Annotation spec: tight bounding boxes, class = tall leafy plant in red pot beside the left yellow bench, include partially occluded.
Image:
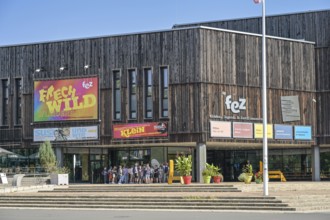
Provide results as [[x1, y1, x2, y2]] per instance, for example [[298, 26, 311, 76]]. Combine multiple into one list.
[[175, 155, 192, 184]]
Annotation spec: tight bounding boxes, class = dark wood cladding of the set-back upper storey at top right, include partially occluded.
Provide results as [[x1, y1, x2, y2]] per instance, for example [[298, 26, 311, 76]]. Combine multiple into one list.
[[174, 10, 330, 47]]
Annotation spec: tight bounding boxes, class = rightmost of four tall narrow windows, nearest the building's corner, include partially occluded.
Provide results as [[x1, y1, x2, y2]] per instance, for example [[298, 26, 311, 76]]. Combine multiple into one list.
[[160, 67, 168, 118]]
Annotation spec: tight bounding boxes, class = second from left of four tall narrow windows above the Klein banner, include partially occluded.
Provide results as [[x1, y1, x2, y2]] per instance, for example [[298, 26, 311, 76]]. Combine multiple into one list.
[[128, 69, 137, 119]]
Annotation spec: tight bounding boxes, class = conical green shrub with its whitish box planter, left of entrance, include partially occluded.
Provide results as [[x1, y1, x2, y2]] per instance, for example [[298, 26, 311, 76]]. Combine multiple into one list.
[[39, 141, 69, 185]]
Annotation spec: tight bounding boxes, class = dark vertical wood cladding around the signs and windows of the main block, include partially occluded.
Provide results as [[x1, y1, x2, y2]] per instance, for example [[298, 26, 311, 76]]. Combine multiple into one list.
[[0, 28, 315, 146]]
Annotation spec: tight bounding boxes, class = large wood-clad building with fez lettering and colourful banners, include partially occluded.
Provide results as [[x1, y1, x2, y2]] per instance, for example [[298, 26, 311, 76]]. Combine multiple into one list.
[[0, 11, 330, 183]]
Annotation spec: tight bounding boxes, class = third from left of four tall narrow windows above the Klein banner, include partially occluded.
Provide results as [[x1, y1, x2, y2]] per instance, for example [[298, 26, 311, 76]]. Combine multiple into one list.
[[144, 68, 152, 118]]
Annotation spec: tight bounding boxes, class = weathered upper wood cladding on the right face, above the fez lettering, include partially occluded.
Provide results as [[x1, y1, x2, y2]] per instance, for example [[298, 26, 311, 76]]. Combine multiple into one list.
[[201, 30, 316, 91]]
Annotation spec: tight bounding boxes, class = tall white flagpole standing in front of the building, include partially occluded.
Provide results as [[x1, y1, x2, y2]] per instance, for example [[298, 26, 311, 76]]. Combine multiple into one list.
[[262, 0, 268, 196]]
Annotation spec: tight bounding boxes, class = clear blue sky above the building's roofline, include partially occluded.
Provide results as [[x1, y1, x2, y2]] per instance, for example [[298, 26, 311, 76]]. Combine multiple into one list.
[[0, 0, 330, 46]]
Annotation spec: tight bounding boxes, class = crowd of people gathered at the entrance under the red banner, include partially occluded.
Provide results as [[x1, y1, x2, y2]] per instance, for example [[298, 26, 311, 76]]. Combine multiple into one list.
[[102, 163, 169, 184]]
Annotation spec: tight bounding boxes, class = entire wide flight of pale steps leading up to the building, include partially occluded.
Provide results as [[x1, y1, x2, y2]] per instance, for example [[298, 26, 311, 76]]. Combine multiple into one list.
[[0, 184, 295, 211]]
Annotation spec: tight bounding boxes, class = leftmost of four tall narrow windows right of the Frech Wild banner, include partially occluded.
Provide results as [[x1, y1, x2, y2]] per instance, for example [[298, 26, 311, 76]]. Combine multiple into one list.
[[113, 71, 121, 120]]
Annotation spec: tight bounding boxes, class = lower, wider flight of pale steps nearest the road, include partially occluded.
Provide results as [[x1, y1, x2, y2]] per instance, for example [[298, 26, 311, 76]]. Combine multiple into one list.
[[0, 196, 295, 211]]
